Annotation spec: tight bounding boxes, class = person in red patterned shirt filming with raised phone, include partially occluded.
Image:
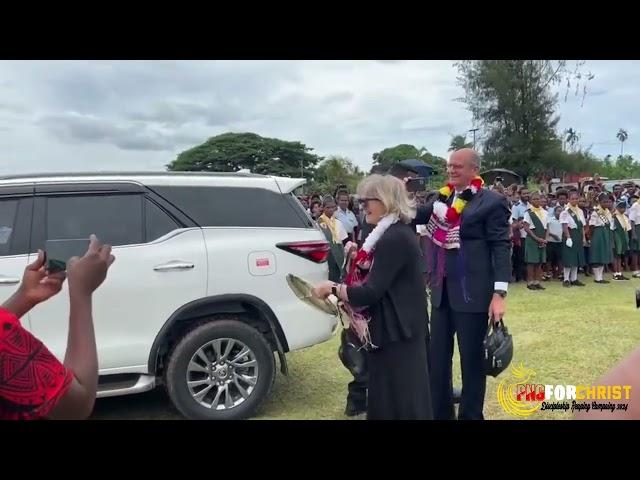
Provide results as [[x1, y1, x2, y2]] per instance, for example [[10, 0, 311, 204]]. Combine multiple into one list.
[[0, 235, 115, 420]]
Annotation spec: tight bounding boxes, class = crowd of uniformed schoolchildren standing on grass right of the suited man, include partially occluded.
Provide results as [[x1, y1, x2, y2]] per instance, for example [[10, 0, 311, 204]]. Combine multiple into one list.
[[494, 179, 640, 284]]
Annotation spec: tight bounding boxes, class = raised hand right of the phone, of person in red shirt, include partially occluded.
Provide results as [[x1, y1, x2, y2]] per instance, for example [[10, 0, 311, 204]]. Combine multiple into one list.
[[67, 235, 115, 296]]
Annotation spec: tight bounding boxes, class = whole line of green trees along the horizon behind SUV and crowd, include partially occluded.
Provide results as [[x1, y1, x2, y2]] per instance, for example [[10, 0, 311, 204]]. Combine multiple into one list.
[[168, 60, 640, 193]]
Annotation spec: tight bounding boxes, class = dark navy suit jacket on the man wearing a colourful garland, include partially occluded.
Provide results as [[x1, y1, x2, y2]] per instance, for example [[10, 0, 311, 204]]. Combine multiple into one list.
[[414, 189, 511, 313]]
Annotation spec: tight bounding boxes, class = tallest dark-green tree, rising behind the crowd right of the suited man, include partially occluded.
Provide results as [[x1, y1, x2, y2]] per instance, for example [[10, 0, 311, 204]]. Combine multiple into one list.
[[456, 60, 593, 176]]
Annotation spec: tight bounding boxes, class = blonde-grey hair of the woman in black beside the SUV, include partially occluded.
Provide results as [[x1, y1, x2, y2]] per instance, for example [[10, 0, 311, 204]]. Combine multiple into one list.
[[358, 174, 416, 223]]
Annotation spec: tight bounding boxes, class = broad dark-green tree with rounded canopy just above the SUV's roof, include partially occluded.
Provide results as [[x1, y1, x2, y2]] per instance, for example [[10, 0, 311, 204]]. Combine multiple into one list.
[[167, 133, 321, 178]]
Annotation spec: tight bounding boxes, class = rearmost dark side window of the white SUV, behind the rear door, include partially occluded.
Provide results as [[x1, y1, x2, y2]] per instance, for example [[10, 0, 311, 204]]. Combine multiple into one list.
[[153, 187, 311, 228]]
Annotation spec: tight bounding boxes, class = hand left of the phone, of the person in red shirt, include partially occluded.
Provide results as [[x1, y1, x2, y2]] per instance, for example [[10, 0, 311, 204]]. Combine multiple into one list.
[[3, 250, 65, 318]]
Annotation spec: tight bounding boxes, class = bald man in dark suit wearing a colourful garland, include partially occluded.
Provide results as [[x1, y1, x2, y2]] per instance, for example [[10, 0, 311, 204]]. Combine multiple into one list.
[[416, 148, 511, 420]]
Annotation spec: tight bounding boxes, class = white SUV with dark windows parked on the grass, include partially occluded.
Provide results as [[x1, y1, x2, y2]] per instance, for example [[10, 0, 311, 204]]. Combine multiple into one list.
[[0, 173, 338, 419]]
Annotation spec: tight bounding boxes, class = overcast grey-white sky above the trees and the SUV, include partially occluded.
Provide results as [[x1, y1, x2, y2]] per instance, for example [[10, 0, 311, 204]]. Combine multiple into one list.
[[0, 60, 640, 174]]
